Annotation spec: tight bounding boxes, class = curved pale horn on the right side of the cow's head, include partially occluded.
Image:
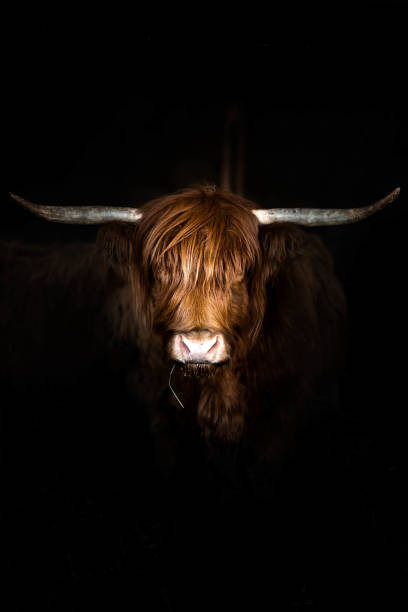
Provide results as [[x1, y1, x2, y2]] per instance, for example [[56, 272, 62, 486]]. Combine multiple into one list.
[[252, 187, 401, 226]]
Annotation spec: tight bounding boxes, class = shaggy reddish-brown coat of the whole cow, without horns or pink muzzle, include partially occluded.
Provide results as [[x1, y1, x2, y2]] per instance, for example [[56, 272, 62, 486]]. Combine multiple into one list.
[[0, 187, 346, 468]]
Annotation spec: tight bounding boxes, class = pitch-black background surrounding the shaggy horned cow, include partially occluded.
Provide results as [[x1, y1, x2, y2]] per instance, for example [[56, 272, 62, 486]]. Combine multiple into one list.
[[1, 2, 408, 610]]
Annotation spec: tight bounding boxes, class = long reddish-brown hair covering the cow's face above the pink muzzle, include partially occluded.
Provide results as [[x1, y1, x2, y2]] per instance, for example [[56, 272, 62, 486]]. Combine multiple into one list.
[[138, 186, 260, 334]]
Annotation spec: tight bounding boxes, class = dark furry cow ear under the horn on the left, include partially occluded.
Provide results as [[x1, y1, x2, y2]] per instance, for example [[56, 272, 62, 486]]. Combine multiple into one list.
[[96, 223, 137, 271]]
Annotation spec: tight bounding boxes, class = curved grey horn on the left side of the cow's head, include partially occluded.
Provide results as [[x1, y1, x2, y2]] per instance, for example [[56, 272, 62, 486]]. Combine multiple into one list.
[[10, 193, 142, 225]]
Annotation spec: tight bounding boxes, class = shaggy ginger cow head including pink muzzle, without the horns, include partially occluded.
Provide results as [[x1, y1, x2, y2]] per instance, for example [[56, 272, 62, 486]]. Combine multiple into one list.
[[135, 187, 264, 368]]
